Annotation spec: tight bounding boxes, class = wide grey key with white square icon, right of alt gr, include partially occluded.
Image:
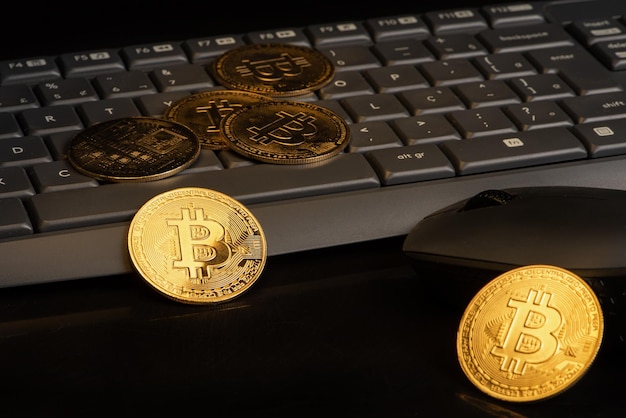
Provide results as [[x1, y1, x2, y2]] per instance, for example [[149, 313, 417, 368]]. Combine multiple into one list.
[[440, 128, 587, 175]]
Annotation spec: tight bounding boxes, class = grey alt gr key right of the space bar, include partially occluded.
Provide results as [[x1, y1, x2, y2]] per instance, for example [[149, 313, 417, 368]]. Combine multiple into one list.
[[365, 144, 455, 186]]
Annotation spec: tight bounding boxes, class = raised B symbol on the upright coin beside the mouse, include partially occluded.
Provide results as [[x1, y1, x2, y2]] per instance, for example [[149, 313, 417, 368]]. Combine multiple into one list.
[[491, 290, 562, 374]]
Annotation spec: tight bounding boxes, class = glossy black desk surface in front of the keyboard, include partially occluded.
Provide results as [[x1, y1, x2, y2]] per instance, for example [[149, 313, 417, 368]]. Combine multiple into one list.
[[0, 239, 626, 417]]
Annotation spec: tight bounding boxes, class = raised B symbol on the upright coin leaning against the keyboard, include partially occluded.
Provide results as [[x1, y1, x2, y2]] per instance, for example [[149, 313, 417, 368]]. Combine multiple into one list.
[[167, 208, 231, 279]]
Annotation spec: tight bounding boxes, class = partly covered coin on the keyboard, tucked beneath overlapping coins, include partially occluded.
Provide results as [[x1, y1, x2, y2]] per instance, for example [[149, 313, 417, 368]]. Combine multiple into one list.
[[163, 90, 273, 150]]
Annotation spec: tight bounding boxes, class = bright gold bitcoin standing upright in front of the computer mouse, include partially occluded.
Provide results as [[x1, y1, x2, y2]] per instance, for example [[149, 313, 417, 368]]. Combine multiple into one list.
[[457, 265, 604, 402]]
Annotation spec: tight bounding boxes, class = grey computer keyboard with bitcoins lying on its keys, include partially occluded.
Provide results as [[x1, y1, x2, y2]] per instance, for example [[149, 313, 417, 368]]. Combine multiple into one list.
[[0, 1, 626, 287]]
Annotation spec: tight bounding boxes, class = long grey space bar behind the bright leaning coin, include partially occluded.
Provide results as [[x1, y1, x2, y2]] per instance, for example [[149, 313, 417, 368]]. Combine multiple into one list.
[[28, 154, 380, 232]]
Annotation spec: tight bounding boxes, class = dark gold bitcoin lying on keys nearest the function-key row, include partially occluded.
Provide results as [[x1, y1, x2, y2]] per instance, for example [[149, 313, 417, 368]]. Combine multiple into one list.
[[213, 43, 335, 97]]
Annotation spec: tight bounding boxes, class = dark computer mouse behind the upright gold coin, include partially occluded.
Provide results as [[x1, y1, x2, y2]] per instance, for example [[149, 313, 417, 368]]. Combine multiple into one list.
[[402, 186, 626, 318]]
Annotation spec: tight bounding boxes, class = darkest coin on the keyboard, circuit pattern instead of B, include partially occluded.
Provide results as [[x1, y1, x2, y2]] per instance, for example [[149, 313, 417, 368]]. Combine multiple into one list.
[[67, 117, 200, 182]]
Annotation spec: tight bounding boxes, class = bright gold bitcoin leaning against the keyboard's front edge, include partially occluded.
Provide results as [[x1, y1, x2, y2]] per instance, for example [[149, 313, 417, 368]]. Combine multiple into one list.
[[128, 187, 267, 304]]
